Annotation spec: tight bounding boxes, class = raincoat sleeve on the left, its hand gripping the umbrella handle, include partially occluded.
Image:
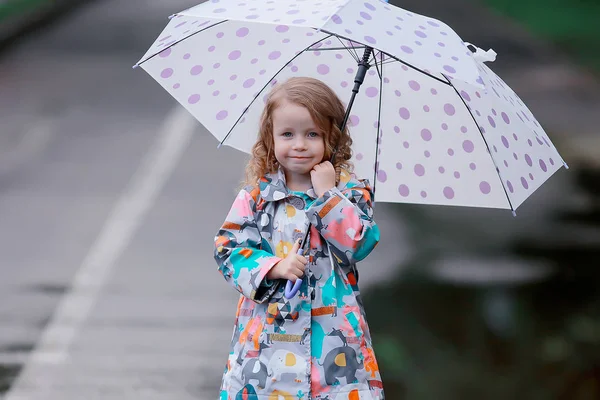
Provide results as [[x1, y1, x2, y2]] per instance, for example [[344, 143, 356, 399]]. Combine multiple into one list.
[[214, 189, 281, 303]]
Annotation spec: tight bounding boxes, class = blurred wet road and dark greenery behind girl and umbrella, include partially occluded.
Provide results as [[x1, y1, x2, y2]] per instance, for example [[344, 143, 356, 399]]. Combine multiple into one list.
[[0, 0, 600, 400]]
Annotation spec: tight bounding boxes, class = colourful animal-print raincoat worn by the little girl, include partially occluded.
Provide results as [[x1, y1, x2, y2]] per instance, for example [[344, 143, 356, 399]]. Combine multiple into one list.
[[215, 171, 384, 400]]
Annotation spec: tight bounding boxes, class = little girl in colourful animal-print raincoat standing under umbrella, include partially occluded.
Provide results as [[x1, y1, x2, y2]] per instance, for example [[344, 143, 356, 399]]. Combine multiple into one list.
[[215, 78, 384, 400]]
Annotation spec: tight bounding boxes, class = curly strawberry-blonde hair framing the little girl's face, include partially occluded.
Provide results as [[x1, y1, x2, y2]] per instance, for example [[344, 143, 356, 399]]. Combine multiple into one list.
[[244, 77, 353, 185]]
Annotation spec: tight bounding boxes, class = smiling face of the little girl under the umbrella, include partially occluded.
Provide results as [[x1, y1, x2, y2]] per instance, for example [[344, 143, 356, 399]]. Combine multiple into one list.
[[272, 100, 325, 182]]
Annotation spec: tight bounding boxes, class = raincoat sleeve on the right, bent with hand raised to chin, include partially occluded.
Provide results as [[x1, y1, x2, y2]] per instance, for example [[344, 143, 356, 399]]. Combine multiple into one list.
[[307, 180, 379, 265]]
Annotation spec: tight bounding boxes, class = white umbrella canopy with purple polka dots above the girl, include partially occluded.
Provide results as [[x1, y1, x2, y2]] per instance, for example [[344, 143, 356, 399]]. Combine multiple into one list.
[[139, 0, 563, 210]]
